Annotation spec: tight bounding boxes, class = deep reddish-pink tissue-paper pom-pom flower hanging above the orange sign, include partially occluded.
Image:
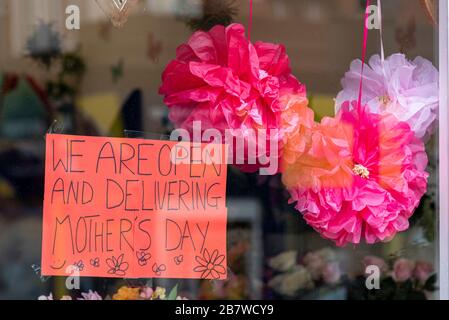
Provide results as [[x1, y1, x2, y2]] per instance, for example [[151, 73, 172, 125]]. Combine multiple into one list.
[[159, 24, 306, 172]]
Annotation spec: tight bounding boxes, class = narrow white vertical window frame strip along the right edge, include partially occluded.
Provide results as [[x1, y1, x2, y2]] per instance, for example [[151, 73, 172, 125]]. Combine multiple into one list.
[[438, 0, 449, 300]]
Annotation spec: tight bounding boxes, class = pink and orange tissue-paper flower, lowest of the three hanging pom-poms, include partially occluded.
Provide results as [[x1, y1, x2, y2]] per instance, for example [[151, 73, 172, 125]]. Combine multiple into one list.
[[283, 102, 428, 246]]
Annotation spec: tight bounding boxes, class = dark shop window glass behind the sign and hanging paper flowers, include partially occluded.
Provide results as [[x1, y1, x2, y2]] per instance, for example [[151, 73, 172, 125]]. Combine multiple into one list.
[[0, 0, 439, 300]]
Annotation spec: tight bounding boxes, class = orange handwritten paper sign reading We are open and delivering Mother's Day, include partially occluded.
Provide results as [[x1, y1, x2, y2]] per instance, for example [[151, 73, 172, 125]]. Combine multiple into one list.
[[42, 134, 227, 279]]
